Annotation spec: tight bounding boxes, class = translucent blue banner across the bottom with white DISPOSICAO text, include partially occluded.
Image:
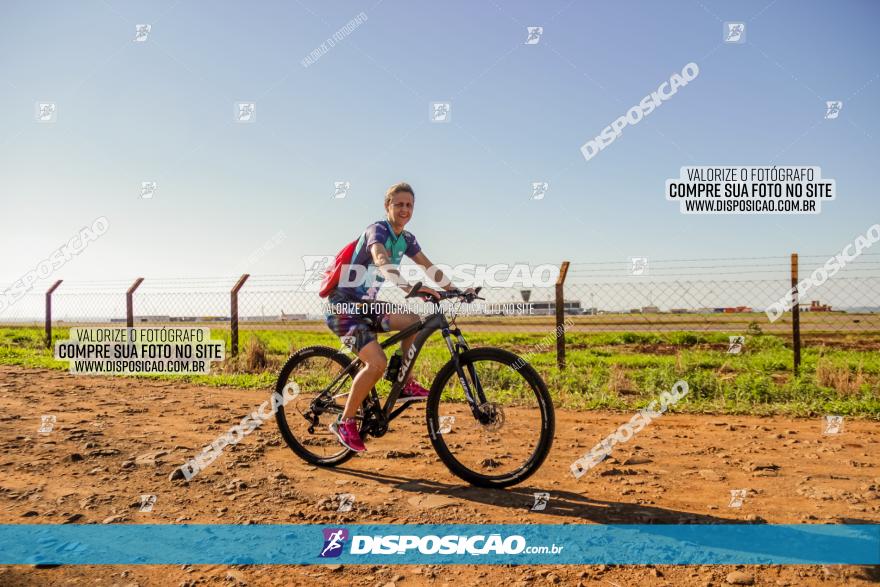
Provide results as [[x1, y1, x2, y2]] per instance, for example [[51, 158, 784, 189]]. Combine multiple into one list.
[[0, 524, 880, 565]]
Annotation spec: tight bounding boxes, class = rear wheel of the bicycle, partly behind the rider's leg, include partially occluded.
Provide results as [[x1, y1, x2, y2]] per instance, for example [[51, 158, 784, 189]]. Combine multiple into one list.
[[275, 346, 363, 467]]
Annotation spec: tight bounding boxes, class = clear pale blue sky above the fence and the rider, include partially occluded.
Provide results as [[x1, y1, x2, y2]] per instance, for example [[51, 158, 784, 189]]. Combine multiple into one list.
[[0, 0, 880, 283]]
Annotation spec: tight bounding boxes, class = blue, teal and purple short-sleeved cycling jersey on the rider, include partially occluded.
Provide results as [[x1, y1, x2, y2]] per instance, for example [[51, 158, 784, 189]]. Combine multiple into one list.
[[336, 220, 422, 302]]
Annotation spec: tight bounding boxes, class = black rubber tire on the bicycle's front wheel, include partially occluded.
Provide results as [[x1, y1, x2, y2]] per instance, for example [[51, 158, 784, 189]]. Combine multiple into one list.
[[425, 347, 556, 488]]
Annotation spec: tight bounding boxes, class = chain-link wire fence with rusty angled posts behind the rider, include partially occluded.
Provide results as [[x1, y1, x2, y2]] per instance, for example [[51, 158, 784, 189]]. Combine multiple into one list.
[[0, 253, 880, 372]]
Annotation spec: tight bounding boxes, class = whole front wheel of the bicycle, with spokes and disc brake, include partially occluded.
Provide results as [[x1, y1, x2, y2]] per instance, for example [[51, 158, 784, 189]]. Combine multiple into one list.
[[426, 348, 555, 487]]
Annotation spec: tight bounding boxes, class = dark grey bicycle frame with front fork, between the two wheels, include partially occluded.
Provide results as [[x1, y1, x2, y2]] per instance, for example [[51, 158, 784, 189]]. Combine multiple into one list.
[[313, 308, 486, 437]]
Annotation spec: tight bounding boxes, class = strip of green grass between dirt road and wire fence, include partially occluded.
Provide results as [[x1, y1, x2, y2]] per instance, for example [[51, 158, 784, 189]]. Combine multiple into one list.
[[0, 327, 880, 419]]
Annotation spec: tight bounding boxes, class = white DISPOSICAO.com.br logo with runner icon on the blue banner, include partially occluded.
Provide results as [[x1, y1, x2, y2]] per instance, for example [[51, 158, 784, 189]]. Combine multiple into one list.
[[319, 528, 564, 558]]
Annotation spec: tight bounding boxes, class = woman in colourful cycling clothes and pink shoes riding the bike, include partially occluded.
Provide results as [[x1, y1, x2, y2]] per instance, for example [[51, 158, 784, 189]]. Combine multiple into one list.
[[327, 183, 473, 452]]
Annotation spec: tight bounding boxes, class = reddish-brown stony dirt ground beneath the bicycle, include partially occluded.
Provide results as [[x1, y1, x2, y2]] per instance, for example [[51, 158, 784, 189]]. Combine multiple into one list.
[[0, 366, 880, 587]]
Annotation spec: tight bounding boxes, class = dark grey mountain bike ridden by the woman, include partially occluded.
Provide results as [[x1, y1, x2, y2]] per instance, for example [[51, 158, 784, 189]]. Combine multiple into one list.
[[275, 283, 555, 488]]
